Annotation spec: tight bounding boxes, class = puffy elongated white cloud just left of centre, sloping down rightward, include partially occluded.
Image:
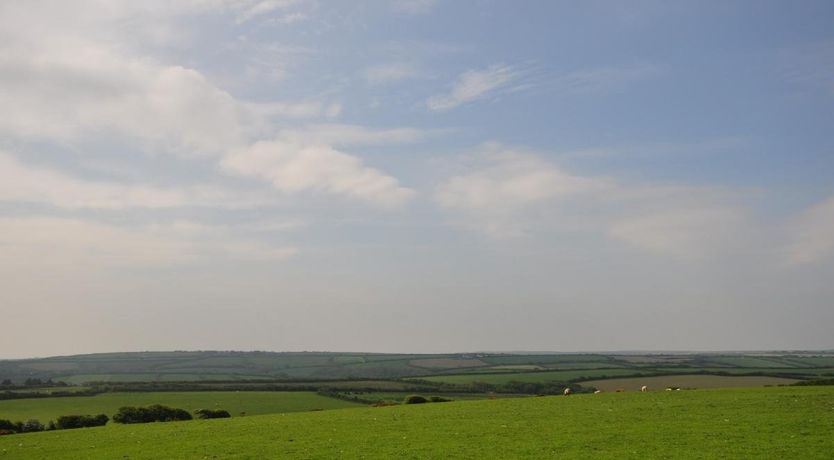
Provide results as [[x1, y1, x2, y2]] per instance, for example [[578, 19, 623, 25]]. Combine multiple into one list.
[[222, 140, 414, 207]]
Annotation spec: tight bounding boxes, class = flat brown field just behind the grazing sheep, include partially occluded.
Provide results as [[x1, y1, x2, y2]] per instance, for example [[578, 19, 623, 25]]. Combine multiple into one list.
[[579, 374, 798, 391]]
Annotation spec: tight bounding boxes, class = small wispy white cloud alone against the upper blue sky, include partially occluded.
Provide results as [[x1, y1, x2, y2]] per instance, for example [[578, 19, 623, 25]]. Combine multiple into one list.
[[426, 65, 523, 111]]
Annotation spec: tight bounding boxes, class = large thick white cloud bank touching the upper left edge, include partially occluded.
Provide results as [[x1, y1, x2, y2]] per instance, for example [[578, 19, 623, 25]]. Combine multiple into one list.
[[0, 36, 250, 155]]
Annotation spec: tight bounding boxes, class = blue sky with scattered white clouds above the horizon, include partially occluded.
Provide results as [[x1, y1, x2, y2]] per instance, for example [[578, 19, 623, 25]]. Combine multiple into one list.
[[0, 0, 834, 358]]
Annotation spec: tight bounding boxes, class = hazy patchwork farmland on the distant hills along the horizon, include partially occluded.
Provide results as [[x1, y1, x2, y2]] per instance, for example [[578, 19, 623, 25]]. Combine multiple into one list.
[[0, 351, 834, 385]]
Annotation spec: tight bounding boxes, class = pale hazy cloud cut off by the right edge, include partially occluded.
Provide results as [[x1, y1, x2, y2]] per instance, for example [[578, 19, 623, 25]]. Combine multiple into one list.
[[788, 197, 834, 265]]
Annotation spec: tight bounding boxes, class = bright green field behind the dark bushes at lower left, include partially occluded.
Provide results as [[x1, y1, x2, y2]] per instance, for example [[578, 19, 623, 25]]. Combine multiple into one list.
[[0, 391, 357, 423]]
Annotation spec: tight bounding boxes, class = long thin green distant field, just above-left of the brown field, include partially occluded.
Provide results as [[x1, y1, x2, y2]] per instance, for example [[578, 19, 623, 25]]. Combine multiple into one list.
[[420, 368, 651, 384]]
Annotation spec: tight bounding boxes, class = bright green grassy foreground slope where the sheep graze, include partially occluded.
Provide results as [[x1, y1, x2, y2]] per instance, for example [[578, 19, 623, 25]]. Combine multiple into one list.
[[0, 387, 834, 459]]
